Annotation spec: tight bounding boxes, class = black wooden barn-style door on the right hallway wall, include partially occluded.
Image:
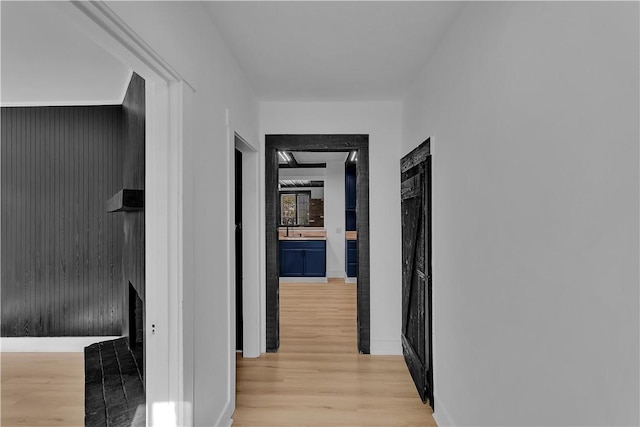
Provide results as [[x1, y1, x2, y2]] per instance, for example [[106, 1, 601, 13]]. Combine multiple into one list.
[[400, 140, 433, 408]]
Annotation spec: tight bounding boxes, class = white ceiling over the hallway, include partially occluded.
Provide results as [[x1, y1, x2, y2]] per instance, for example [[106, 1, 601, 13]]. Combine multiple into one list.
[[206, 1, 464, 100]]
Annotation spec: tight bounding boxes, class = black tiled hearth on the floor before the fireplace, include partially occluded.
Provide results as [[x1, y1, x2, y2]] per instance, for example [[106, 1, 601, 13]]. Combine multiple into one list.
[[84, 338, 146, 427]]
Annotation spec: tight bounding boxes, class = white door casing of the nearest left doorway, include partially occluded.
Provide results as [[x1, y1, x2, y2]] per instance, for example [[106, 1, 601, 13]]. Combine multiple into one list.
[[57, 2, 193, 416]]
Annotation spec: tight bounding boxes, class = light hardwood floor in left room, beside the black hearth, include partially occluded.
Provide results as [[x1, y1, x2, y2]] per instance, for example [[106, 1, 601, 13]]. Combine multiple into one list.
[[0, 353, 84, 427]]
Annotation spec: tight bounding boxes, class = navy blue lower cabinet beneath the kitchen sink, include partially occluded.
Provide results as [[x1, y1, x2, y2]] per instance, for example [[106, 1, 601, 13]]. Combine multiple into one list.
[[280, 240, 327, 277]]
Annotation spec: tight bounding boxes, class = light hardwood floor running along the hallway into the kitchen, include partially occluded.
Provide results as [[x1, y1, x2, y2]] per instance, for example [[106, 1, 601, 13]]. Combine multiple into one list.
[[233, 282, 436, 427]]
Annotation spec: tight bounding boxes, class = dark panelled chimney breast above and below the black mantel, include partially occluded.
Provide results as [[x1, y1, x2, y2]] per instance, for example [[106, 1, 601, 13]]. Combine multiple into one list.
[[120, 73, 145, 336]]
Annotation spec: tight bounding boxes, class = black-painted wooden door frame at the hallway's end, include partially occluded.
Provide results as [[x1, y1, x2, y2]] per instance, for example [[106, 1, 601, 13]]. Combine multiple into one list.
[[265, 135, 371, 354]]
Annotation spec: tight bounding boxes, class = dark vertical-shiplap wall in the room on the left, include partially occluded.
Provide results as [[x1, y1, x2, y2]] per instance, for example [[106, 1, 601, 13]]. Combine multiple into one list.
[[1, 106, 123, 336]]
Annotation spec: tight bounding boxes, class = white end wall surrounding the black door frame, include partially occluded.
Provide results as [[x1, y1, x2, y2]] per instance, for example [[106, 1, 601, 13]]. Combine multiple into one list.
[[260, 102, 401, 354]]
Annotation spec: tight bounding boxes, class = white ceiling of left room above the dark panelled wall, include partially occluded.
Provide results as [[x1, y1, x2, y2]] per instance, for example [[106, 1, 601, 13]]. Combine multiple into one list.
[[0, 1, 131, 105]]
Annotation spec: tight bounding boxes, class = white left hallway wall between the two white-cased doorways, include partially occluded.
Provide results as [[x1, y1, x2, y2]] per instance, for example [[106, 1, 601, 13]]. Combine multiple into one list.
[[109, 2, 258, 426]]
